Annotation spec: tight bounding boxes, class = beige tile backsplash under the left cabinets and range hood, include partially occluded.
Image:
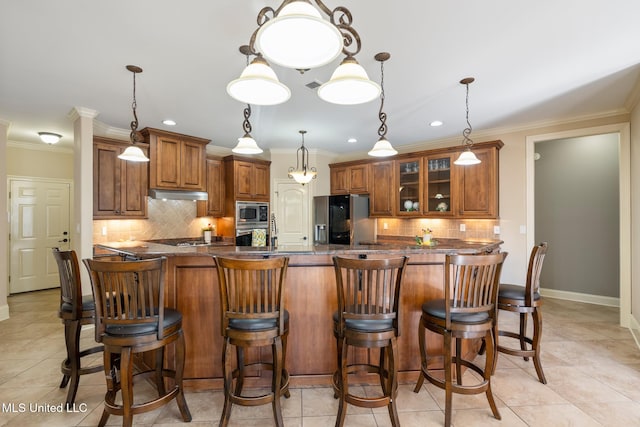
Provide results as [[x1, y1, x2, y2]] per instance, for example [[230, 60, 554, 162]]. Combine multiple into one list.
[[93, 199, 216, 243]]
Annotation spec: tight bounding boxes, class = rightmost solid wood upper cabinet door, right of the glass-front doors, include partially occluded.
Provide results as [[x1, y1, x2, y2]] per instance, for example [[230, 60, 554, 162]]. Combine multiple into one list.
[[456, 147, 498, 218]]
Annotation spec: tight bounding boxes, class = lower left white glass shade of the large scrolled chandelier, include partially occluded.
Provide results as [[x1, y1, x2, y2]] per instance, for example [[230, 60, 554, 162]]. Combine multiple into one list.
[[227, 56, 291, 105]]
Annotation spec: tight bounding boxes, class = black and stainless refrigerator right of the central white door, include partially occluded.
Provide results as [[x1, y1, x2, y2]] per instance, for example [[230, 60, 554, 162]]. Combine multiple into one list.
[[313, 194, 376, 245]]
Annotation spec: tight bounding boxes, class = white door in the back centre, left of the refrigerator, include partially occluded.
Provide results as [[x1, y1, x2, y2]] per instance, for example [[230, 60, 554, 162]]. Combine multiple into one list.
[[275, 181, 311, 246]]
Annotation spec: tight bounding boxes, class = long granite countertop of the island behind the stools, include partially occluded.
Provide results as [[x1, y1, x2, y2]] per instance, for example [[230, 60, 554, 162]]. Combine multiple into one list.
[[96, 238, 504, 258]]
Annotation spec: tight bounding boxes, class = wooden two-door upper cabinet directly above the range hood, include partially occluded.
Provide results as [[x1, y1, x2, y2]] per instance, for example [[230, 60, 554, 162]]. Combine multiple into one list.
[[142, 128, 209, 191]]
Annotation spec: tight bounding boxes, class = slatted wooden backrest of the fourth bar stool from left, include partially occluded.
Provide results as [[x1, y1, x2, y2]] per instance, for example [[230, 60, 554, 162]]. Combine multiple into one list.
[[333, 256, 409, 335]]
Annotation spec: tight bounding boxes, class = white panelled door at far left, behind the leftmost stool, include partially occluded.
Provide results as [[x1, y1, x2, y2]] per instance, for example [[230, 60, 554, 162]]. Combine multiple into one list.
[[9, 179, 70, 294]]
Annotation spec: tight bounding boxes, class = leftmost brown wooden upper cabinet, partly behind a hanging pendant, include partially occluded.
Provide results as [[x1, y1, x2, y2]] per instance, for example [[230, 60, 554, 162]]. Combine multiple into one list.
[[93, 136, 148, 219]]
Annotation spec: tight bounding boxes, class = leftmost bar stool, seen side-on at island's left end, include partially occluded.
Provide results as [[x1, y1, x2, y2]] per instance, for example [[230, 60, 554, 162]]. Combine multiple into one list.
[[53, 248, 103, 407]]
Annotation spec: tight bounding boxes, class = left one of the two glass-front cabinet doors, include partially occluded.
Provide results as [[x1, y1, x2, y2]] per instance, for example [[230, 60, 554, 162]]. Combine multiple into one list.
[[396, 157, 422, 216]]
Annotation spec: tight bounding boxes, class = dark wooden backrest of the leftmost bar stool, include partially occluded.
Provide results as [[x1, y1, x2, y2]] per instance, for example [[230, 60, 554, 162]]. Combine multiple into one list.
[[53, 248, 82, 319]]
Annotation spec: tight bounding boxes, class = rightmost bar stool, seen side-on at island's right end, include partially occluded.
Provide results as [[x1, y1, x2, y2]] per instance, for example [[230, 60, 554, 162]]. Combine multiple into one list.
[[494, 242, 547, 384]]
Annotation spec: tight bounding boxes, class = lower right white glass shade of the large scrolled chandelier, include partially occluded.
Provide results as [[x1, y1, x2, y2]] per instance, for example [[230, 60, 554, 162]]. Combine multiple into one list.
[[318, 58, 381, 105]]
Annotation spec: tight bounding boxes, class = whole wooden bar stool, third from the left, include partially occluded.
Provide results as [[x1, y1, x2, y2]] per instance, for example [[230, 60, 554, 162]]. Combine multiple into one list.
[[214, 257, 290, 427]]
